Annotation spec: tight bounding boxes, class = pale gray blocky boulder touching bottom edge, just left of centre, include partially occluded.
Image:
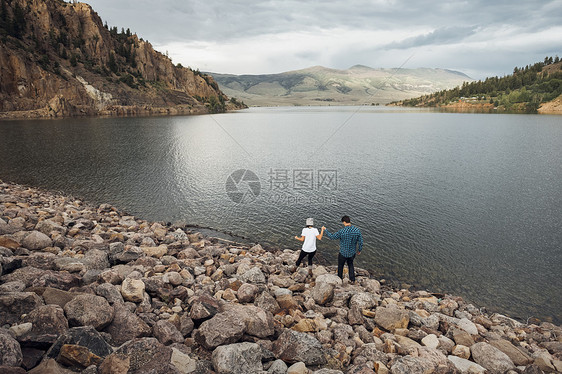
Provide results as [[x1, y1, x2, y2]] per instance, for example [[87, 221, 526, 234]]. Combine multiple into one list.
[[212, 342, 263, 374]]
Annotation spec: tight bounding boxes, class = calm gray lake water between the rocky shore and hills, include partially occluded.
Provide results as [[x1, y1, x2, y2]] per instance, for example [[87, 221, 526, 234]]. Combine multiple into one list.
[[0, 107, 562, 324]]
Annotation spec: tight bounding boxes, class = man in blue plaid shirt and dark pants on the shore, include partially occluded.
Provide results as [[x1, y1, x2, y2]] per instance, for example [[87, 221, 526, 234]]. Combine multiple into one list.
[[322, 216, 363, 283]]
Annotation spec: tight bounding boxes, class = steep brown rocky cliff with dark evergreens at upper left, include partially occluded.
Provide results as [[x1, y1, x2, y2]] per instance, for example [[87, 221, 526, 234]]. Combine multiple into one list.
[[0, 0, 243, 118]]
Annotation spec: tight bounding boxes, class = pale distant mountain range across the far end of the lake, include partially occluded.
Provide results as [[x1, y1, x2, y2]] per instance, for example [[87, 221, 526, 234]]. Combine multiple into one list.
[[209, 65, 473, 106]]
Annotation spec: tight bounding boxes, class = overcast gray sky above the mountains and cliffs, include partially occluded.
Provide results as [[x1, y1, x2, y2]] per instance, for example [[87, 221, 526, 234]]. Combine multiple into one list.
[[86, 0, 562, 79]]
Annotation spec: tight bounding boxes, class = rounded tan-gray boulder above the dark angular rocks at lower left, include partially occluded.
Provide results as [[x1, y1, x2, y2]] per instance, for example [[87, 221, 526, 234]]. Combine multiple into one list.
[[64, 294, 114, 330]]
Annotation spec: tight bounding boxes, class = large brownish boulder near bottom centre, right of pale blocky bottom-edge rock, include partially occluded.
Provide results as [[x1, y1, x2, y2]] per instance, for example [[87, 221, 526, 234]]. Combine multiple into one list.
[[272, 329, 327, 366]]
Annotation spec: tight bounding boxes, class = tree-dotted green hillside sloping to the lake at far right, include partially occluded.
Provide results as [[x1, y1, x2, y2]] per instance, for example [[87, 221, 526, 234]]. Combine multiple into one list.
[[393, 56, 562, 113]]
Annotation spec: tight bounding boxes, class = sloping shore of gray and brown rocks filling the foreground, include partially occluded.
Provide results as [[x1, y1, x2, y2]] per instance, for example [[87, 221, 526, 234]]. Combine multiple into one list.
[[0, 181, 562, 374]]
